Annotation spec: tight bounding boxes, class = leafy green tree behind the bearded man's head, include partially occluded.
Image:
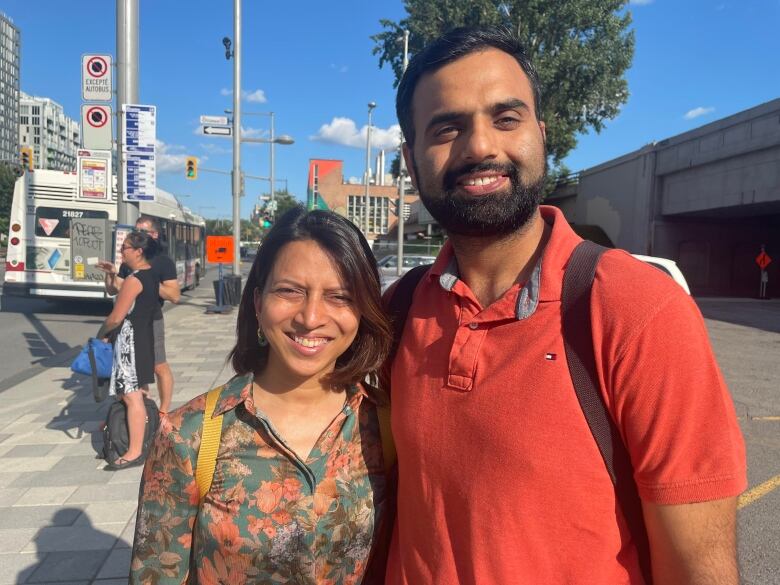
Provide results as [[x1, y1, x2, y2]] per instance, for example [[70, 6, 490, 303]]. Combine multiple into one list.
[[371, 0, 634, 167]]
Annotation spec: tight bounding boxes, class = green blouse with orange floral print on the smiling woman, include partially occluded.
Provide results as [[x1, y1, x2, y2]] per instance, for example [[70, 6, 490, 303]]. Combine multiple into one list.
[[130, 375, 394, 585]]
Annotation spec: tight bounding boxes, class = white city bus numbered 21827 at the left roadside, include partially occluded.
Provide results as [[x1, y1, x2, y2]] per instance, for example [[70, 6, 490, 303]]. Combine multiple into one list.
[[3, 170, 206, 300]]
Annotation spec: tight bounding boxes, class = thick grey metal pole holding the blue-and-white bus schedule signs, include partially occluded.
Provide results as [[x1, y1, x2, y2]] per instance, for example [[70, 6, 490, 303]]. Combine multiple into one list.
[[116, 0, 138, 225]]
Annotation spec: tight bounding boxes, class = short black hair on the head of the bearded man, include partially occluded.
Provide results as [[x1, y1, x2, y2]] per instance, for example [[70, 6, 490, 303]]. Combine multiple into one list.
[[395, 27, 541, 147]]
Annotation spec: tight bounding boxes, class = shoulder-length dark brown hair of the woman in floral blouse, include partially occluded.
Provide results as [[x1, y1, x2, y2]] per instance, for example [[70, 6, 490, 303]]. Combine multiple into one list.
[[229, 207, 392, 386]]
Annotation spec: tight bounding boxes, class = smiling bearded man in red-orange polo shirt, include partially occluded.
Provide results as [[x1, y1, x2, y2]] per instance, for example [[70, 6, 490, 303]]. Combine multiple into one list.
[[387, 29, 746, 585]]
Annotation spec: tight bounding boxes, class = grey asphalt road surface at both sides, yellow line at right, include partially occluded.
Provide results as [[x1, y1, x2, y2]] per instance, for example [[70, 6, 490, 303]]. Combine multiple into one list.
[[0, 262, 780, 585]]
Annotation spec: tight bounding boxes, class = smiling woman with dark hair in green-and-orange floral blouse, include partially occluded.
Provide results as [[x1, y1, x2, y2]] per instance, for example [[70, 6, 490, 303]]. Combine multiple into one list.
[[131, 209, 391, 585]]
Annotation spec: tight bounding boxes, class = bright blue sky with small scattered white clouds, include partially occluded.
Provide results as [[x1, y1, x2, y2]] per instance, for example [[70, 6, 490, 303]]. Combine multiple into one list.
[[0, 0, 780, 217]]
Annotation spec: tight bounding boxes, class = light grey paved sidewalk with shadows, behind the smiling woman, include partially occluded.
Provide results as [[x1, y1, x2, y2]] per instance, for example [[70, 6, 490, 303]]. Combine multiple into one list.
[[0, 286, 238, 585]]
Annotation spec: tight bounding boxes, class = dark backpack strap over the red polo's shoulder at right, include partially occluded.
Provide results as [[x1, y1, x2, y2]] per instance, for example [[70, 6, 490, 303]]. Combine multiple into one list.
[[561, 240, 652, 583]]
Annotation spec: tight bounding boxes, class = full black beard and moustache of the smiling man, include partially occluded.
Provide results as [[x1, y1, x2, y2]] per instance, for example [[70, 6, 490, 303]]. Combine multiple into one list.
[[414, 155, 547, 237]]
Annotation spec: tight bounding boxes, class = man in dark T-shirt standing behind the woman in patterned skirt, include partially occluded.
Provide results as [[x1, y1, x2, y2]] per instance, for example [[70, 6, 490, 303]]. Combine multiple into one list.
[[97, 215, 181, 414]]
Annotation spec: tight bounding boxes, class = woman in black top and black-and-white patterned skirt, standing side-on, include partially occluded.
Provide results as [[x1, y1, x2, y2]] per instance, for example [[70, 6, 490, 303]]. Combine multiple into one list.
[[97, 232, 160, 469]]
